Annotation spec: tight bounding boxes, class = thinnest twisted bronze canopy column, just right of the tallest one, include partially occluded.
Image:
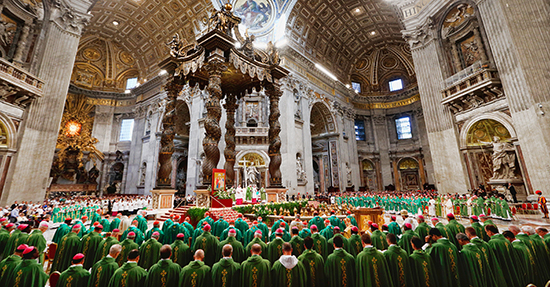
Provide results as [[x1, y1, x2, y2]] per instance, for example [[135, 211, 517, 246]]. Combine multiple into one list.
[[223, 95, 237, 187]]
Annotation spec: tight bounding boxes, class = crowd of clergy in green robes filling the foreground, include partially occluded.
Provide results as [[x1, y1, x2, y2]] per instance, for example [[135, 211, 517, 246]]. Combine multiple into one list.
[[0, 194, 550, 287]]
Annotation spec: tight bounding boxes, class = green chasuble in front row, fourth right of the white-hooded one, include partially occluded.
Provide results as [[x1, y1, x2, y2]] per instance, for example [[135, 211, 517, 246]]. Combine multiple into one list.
[[384, 245, 413, 287]]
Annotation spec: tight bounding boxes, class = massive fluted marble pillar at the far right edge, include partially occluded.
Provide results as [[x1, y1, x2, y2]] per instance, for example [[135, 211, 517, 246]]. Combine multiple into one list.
[[478, 0, 550, 193]]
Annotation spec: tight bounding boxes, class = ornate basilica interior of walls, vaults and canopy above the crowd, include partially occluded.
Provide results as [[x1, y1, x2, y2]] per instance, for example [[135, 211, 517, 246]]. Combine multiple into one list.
[[0, 0, 550, 205]]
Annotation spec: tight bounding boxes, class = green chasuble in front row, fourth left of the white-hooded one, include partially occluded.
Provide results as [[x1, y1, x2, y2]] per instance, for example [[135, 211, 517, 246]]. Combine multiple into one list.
[[145, 259, 181, 287]]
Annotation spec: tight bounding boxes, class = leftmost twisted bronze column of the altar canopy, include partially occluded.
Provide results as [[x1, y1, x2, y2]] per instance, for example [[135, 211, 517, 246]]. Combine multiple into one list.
[[157, 78, 183, 188]]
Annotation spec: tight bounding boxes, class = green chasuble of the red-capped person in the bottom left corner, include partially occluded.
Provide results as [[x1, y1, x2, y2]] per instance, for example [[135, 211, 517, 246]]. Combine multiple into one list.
[[2, 259, 48, 287]]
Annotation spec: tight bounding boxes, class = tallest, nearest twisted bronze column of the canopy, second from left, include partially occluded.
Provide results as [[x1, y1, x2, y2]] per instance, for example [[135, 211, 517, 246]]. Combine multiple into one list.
[[202, 59, 227, 186]]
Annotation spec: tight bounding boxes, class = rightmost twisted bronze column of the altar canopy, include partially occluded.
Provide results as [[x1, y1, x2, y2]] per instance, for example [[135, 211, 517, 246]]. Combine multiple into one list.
[[265, 82, 283, 187]]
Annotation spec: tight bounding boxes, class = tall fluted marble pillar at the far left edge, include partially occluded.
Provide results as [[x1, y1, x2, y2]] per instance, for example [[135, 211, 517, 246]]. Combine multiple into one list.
[[0, 0, 92, 205]]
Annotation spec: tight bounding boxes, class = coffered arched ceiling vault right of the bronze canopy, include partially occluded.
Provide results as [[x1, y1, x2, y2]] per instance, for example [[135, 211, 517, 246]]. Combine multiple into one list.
[[286, 0, 405, 82]]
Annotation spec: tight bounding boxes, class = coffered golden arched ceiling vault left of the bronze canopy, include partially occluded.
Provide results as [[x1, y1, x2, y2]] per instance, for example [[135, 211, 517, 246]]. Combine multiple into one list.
[[83, 0, 214, 77]]
